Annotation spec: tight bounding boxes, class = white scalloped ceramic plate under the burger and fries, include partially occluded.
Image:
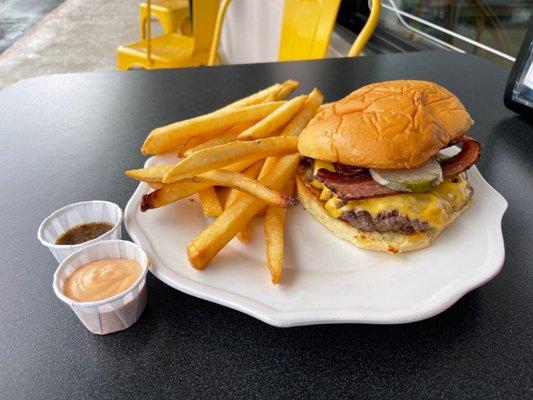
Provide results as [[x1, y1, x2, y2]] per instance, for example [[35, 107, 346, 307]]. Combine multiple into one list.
[[125, 149, 507, 327]]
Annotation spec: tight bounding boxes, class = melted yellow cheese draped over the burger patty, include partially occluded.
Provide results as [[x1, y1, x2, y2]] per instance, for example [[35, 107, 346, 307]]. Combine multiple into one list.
[[312, 161, 470, 229]]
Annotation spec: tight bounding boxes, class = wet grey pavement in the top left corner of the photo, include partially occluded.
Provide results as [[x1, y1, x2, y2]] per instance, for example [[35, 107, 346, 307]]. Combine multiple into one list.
[[0, 0, 64, 53]]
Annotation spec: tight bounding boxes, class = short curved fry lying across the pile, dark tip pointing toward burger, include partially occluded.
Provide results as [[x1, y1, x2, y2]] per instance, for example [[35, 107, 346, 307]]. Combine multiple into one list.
[[188, 169, 296, 208]]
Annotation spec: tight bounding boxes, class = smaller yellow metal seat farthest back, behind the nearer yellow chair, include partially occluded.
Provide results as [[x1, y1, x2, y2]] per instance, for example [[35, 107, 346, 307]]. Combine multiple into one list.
[[139, 0, 189, 39]]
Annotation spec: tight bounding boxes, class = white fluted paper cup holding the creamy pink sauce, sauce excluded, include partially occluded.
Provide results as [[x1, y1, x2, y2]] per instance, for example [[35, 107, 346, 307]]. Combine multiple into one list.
[[53, 240, 150, 335]]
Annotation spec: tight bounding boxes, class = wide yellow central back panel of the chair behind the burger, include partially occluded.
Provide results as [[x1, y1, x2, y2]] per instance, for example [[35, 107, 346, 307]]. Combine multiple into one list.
[[278, 0, 340, 61]]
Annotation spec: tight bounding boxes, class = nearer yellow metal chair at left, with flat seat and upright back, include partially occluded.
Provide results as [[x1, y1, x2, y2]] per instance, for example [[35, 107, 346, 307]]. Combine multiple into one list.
[[117, 0, 220, 71]]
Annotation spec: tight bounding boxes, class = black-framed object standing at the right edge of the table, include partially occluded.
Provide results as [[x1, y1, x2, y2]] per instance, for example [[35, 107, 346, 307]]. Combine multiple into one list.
[[503, 17, 533, 118]]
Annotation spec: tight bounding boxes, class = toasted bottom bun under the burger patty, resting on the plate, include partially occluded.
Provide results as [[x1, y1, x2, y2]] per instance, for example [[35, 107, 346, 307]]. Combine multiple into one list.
[[296, 173, 473, 253]]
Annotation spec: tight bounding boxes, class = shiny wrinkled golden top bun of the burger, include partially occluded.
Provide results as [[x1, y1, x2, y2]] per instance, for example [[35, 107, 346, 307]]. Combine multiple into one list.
[[298, 80, 474, 169]]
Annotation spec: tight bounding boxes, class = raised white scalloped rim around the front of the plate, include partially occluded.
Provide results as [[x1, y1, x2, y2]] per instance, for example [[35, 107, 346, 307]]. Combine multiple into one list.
[[124, 157, 508, 327]]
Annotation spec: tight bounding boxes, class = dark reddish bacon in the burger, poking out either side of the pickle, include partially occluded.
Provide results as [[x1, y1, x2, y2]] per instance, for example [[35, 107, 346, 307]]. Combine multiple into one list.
[[315, 138, 481, 201]]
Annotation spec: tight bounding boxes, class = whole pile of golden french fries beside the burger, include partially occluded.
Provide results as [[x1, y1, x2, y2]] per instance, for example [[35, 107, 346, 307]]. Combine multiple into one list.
[[126, 80, 323, 284]]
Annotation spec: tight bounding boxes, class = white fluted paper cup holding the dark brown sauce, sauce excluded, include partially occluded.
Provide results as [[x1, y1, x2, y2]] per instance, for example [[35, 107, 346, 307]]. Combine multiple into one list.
[[37, 200, 124, 262]]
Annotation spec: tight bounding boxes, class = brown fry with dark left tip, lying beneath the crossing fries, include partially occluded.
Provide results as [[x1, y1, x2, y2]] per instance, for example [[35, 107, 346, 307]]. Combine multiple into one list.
[[141, 160, 255, 211]]
